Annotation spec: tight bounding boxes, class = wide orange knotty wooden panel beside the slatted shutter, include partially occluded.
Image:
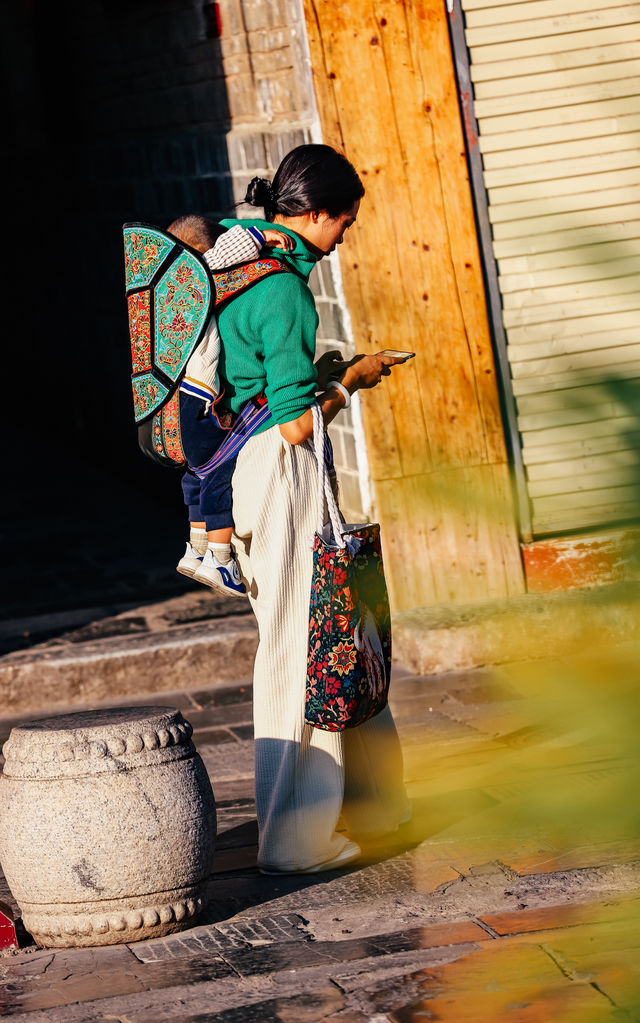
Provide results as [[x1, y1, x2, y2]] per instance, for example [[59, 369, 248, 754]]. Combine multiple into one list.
[[305, 0, 523, 609]]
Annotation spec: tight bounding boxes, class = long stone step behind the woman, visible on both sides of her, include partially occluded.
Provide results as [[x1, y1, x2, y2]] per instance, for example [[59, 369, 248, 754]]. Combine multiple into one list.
[[0, 583, 640, 715]]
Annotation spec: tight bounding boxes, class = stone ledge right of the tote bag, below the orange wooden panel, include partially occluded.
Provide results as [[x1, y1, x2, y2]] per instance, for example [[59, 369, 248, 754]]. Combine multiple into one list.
[[394, 583, 640, 675]]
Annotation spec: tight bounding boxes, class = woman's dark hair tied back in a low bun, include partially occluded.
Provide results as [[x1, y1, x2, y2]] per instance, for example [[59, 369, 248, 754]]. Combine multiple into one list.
[[244, 145, 364, 220]]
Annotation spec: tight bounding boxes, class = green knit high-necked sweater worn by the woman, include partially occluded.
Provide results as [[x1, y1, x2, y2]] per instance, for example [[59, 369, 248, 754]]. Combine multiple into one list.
[[218, 219, 318, 433]]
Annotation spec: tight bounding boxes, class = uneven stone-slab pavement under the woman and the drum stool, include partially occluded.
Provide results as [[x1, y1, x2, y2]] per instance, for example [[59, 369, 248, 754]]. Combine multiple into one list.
[[0, 646, 640, 1023]]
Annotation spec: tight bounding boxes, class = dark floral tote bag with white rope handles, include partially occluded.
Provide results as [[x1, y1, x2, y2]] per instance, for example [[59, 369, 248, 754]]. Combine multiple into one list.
[[305, 405, 392, 731]]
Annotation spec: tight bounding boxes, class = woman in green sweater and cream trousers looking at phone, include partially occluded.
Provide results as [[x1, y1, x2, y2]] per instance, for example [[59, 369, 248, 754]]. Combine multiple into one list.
[[219, 145, 409, 874]]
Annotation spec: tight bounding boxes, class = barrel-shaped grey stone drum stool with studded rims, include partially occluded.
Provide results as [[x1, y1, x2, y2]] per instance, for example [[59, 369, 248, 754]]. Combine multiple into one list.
[[0, 707, 216, 947]]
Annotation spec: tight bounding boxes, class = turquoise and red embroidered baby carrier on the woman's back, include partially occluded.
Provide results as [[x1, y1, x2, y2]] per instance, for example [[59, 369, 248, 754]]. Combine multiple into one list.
[[123, 223, 288, 466]]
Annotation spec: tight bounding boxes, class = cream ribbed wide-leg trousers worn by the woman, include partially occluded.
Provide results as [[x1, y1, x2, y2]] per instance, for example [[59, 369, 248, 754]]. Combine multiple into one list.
[[233, 427, 408, 871]]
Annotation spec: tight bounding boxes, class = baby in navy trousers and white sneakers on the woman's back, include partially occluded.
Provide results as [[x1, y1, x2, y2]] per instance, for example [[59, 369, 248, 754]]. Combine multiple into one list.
[[168, 215, 293, 596]]
